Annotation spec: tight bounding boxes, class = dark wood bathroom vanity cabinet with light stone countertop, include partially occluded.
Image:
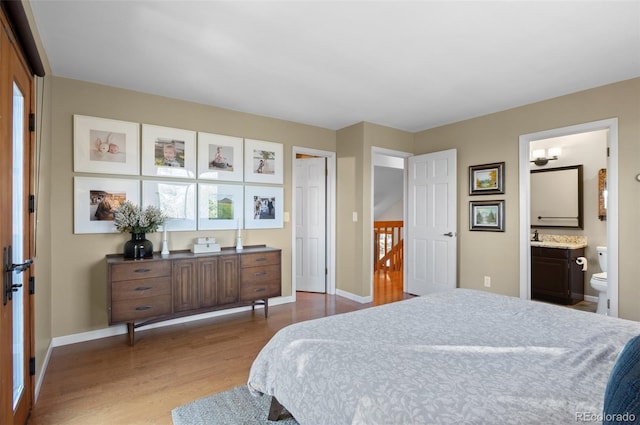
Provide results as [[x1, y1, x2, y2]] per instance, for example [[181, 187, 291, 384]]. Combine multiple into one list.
[[531, 242, 585, 305]]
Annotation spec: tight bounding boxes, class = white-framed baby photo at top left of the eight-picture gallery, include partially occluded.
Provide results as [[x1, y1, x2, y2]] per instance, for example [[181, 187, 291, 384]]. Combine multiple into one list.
[[73, 115, 140, 175]]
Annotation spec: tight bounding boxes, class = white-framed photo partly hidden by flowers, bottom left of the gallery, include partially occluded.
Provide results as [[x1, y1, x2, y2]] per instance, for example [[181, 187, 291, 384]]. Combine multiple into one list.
[[73, 177, 140, 233]]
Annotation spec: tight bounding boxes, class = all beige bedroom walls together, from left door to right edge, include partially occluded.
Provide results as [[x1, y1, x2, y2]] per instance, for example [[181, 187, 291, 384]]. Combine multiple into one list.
[[42, 78, 640, 344]]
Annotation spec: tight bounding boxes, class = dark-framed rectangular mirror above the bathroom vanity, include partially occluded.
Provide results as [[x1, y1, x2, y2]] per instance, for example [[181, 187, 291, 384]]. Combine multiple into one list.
[[531, 165, 584, 229]]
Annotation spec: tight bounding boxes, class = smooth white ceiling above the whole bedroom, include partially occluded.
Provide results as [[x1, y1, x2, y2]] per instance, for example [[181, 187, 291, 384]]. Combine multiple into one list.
[[30, 0, 640, 131]]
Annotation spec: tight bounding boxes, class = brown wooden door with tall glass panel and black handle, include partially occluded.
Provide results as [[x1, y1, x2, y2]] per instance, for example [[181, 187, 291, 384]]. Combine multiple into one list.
[[0, 7, 34, 425]]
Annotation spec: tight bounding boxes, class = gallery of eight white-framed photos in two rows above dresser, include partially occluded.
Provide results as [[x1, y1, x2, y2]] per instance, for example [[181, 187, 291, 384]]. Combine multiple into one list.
[[73, 115, 284, 234]]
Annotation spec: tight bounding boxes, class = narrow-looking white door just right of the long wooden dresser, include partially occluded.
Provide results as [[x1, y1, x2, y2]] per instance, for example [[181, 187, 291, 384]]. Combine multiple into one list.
[[295, 158, 327, 292]]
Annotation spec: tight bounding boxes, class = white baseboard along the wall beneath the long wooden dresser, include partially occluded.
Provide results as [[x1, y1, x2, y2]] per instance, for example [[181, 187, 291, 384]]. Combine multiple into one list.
[[51, 296, 295, 347]]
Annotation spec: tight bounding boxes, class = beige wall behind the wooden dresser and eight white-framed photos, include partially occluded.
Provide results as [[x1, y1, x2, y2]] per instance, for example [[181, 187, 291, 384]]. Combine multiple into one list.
[[48, 77, 336, 337]]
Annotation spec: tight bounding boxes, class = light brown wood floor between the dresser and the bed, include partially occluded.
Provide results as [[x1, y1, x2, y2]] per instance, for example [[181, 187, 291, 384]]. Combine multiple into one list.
[[29, 273, 409, 425]]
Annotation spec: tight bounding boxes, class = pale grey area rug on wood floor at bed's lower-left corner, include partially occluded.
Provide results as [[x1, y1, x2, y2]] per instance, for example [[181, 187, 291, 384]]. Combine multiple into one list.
[[171, 385, 298, 425]]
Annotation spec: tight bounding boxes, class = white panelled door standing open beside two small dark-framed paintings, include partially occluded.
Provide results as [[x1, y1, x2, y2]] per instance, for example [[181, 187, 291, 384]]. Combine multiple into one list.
[[405, 149, 457, 295]]
